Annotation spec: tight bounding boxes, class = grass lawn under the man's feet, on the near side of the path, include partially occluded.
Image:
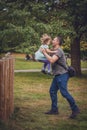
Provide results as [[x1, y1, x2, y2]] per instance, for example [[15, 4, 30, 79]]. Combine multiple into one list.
[[0, 71, 87, 130]]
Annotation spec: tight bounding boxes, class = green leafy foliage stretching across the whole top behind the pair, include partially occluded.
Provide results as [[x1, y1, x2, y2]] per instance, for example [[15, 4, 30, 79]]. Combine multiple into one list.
[[0, 0, 87, 53]]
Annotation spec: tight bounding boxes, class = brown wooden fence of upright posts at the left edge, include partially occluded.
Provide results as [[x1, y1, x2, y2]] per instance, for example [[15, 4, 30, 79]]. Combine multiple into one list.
[[0, 56, 14, 121]]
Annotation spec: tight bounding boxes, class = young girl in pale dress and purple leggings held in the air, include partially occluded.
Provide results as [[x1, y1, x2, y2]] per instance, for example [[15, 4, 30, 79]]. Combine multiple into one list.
[[35, 34, 51, 74]]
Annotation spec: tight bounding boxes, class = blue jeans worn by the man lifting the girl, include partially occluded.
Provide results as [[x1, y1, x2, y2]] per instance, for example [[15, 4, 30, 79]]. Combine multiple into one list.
[[50, 73, 78, 111]]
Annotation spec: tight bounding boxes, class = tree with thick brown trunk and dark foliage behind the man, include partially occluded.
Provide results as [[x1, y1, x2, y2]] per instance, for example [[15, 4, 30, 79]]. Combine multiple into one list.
[[45, 0, 87, 76]]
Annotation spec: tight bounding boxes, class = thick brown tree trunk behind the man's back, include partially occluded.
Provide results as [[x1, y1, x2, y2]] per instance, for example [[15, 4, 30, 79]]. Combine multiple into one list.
[[71, 37, 81, 76]]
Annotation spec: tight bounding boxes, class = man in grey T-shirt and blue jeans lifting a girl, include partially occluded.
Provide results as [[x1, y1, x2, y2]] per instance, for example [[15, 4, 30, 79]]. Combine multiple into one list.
[[42, 37, 80, 118]]
